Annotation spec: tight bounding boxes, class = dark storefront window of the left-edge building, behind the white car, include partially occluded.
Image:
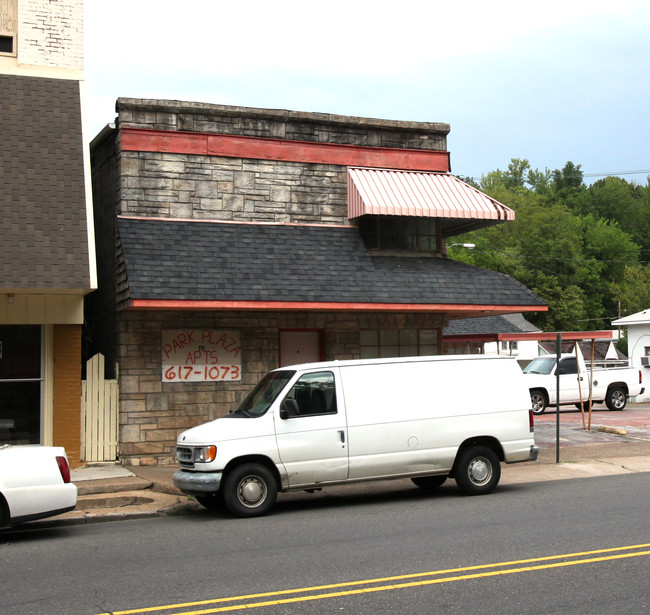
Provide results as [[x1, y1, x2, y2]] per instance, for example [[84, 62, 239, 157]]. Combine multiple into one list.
[[0, 325, 43, 444]]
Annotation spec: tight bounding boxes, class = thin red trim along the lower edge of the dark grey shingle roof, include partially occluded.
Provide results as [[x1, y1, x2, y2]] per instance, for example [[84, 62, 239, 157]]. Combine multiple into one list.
[[130, 299, 548, 314]]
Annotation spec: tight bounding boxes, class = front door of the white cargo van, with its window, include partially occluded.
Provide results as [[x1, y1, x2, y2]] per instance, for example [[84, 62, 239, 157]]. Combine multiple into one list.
[[274, 371, 348, 487]]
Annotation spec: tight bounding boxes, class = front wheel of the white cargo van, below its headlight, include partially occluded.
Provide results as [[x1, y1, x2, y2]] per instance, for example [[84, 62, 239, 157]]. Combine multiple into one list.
[[223, 463, 278, 517]]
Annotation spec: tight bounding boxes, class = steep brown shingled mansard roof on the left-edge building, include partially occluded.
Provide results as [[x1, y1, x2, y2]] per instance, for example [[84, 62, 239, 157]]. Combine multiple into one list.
[[0, 75, 94, 292]]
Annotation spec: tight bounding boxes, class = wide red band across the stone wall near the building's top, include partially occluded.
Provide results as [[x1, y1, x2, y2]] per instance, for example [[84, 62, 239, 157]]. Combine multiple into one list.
[[121, 128, 450, 173]]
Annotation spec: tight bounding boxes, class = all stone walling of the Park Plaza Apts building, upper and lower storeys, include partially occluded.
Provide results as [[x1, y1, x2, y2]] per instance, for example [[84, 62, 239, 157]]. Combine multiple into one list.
[[87, 99, 456, 465]]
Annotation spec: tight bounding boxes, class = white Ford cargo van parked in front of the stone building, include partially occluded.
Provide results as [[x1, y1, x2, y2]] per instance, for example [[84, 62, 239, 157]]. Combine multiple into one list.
[[174, 356, 538, 517]]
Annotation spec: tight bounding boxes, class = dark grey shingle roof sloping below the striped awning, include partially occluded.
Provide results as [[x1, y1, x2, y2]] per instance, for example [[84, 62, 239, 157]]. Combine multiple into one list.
[[118, 218, 546, 307]]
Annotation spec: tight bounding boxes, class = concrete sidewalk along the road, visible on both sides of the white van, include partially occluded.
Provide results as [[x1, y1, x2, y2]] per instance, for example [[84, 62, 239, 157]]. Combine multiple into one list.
[[25, 415, 650, 527]]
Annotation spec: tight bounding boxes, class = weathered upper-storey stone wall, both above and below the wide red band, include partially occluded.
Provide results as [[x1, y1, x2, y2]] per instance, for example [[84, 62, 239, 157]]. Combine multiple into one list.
[[112, 98, 449, 224]]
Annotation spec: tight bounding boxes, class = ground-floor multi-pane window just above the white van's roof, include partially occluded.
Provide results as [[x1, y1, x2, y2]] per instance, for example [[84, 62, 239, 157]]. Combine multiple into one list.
[[360, 329, 438, 359]]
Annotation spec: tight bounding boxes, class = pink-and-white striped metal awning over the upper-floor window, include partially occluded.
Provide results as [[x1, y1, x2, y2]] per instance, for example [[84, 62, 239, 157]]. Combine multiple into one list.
[[348, 167, 515, 237]]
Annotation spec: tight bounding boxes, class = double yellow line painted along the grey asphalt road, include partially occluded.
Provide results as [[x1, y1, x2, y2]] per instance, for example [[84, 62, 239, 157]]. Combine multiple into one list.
[[100, 543, 650, 615]]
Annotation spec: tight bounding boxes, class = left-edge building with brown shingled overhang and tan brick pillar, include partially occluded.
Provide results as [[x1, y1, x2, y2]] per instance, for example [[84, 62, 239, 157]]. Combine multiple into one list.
[[0, 0, 96, 465]]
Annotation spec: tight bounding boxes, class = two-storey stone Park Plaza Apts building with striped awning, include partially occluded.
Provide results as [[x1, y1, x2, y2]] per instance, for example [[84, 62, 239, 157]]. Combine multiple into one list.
[[87, 99, 547, 464]]
